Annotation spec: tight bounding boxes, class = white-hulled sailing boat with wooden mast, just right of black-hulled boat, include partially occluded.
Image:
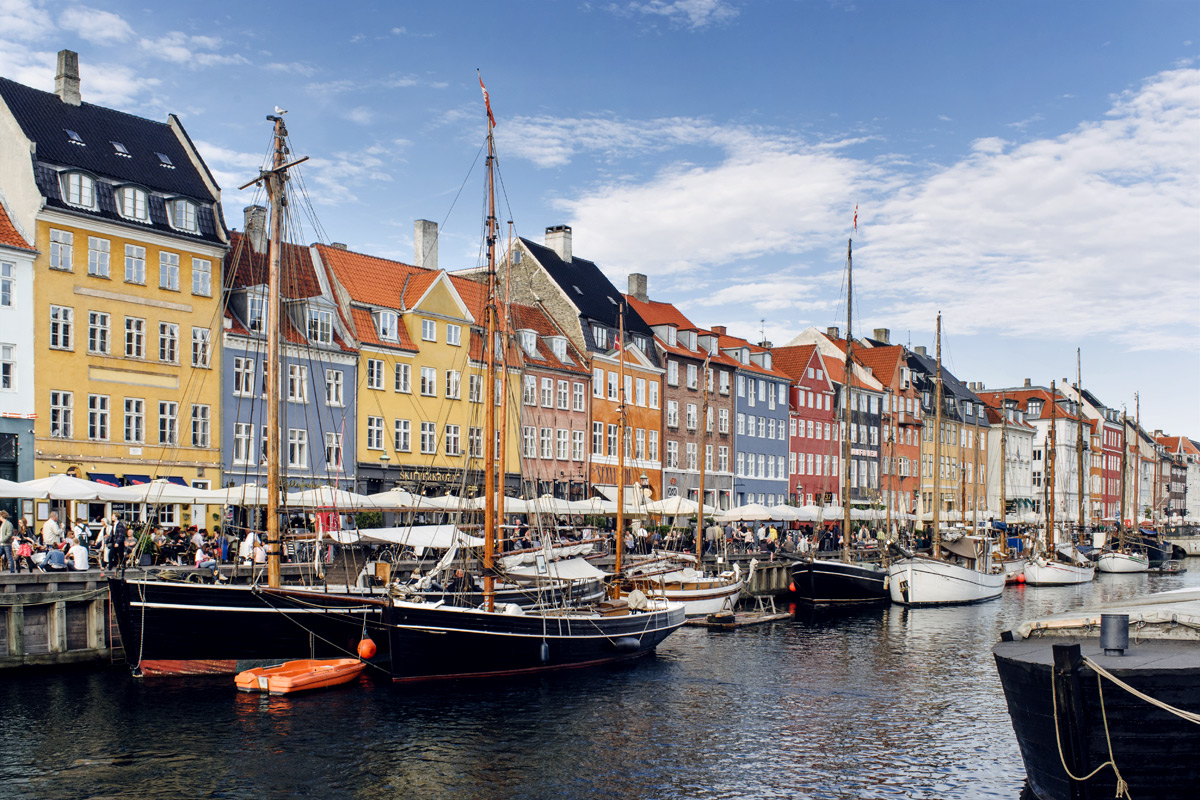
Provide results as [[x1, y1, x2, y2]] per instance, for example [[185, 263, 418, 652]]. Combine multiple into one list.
[[888, 314, 1004, 606]]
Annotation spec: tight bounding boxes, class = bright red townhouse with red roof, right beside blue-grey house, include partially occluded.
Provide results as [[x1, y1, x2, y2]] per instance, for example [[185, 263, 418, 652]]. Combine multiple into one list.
[[772, 344, 840, 505]]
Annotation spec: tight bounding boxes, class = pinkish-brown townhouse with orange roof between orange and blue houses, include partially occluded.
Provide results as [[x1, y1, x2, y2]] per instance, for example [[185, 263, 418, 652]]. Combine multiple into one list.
[[625, 273, 737, 509]]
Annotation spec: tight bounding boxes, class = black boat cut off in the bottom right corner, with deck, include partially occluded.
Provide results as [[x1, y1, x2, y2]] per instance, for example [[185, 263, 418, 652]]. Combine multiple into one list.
[[992, 591, 1200, 800]]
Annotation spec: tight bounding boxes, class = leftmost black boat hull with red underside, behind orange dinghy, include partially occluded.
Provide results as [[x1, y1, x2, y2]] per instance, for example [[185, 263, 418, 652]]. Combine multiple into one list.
[[109, 578, 386, 675]]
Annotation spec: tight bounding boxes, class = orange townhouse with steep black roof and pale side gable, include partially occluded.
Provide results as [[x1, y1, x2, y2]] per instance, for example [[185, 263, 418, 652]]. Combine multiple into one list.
[[500, 225, 666, 505]]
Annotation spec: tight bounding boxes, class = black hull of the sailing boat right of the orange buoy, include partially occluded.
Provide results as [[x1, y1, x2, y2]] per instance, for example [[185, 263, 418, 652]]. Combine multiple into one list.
[[383, 600, 685, 682]]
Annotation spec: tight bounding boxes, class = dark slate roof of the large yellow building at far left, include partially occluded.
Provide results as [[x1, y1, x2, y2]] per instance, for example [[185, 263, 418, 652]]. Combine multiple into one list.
[[0, 78, 223, 242]]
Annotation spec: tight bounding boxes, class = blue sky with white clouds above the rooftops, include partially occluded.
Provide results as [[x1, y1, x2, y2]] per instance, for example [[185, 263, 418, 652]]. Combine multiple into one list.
[[0, 0, 1200, 439]]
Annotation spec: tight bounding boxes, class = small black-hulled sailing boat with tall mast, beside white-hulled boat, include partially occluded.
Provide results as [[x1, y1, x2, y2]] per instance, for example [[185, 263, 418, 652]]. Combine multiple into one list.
[[792, 240, 888, 606]]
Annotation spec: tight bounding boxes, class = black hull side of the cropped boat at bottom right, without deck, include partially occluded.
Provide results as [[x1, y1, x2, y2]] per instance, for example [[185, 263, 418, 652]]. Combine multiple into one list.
[[992, 637, 1200, 800]]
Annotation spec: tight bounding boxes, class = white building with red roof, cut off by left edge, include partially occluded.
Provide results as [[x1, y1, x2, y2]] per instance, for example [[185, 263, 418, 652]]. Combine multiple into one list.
[[0, 199, 37, 503]]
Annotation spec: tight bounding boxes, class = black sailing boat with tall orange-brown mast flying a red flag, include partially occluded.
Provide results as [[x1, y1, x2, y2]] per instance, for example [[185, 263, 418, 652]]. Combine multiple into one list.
[[372, 78, 684, 682]]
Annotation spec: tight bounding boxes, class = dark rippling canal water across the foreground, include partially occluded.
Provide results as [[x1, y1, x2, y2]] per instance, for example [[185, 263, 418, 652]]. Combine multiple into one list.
[[0, 559, 1200, 800]]
